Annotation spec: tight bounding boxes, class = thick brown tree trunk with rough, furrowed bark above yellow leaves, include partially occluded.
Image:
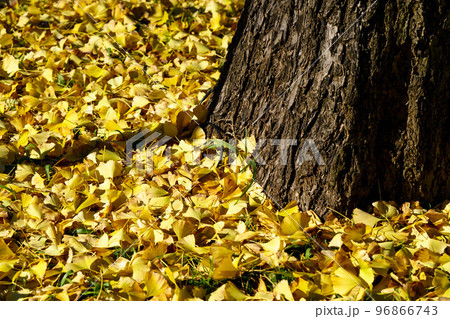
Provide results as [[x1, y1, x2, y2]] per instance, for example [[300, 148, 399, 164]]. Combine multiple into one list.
[[208, 0, 450, 216]]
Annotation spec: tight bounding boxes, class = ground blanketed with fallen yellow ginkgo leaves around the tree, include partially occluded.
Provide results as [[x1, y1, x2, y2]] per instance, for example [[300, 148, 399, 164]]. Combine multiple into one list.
[[0, 0, 450, 300]]
